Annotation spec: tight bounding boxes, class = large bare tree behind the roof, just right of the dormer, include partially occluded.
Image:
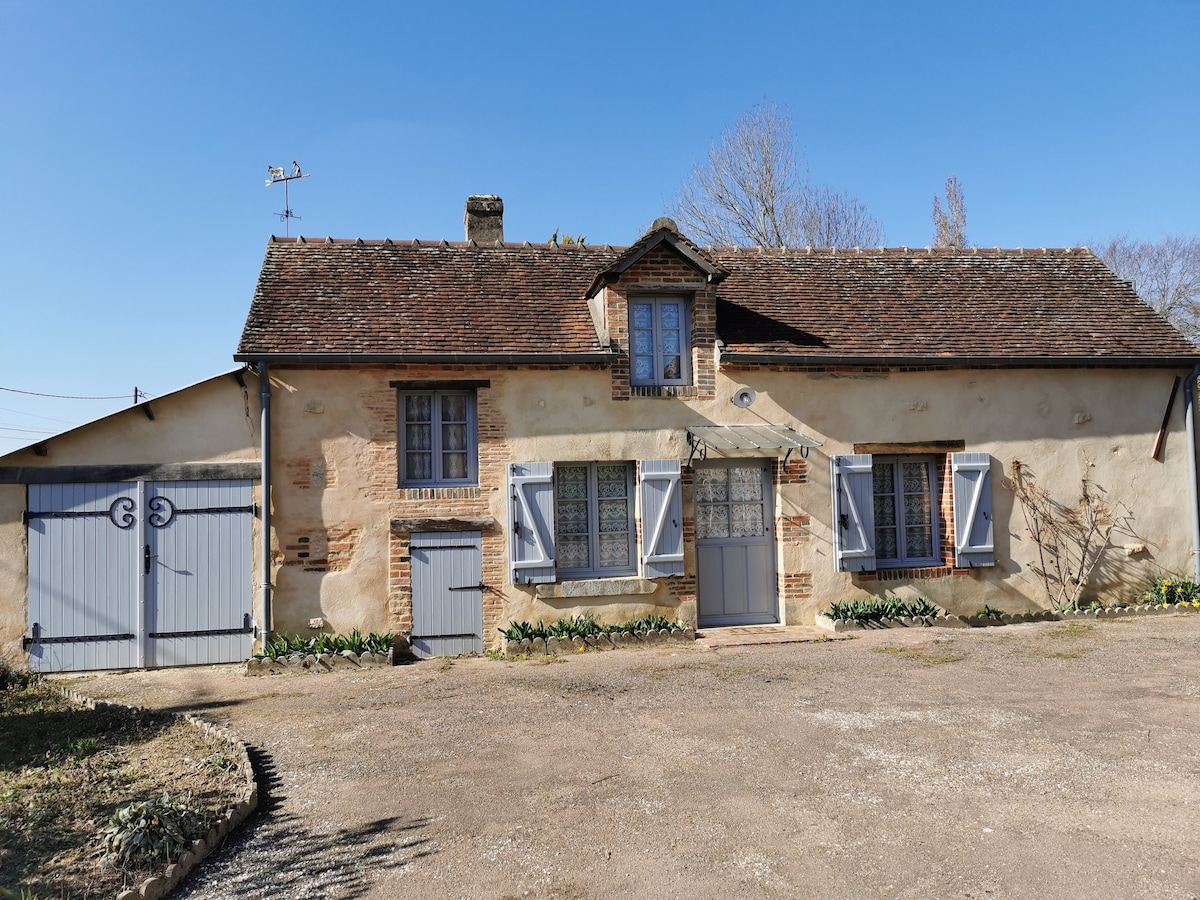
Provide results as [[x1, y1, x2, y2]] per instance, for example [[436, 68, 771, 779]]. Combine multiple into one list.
[[670, 103, 883, 247]]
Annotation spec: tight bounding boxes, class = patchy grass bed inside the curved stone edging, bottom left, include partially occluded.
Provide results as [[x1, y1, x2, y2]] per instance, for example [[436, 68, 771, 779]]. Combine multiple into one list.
[[0, 683, 241, 900]]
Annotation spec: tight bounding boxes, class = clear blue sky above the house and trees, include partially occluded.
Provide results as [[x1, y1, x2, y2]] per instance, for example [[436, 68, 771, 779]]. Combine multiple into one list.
[[0, 0, 1200, 452]]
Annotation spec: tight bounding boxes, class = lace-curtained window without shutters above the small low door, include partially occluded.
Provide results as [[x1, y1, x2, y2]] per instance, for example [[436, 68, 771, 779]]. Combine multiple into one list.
[[400, 390, 479, 487]]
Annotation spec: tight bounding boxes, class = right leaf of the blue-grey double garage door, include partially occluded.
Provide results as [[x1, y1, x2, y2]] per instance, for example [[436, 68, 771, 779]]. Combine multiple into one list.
[[143, 481, 253, 666]]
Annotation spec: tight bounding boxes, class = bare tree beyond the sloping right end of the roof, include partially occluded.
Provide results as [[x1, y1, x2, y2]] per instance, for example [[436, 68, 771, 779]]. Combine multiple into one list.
[[1092, 234, 1200, 343]]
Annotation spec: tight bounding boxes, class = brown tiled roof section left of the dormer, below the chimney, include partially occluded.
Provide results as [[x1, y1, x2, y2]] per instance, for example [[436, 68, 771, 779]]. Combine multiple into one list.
[[238, 239, 619, 359]]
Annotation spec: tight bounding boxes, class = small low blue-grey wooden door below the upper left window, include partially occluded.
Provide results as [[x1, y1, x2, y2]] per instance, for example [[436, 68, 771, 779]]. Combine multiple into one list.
[[409, 532, 484, 658]]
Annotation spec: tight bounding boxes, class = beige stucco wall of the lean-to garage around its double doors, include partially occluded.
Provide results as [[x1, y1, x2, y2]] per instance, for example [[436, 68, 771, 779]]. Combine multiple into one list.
[[0, 371, 263, 660]]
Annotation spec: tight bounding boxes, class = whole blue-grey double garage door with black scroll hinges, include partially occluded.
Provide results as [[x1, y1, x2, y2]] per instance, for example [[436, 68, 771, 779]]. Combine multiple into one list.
[[26, 481, 253, 672]]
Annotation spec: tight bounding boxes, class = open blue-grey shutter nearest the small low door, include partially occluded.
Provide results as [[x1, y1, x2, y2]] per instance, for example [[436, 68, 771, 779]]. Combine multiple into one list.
[[509, 462, 554, 584]]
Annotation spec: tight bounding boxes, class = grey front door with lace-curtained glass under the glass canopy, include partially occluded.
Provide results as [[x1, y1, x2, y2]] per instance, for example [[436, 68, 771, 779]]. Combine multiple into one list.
[[692, 460, 779, 628]]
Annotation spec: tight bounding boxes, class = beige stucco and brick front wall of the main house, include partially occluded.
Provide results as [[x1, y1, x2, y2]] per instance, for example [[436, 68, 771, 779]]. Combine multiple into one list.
[[271, 366, 1190, 642]]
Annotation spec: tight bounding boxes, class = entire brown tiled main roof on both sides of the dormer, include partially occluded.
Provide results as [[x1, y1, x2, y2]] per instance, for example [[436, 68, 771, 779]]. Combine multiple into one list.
[[236, 239, 1200, 365]]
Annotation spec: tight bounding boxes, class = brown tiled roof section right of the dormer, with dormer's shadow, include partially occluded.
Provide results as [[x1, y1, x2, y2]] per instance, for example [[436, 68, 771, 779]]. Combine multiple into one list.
[[712, 248, 1200, 360]]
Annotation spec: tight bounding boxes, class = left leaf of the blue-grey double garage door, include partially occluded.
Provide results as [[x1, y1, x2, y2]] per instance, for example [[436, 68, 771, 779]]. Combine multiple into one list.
[[26, 484, 142, 672]]
